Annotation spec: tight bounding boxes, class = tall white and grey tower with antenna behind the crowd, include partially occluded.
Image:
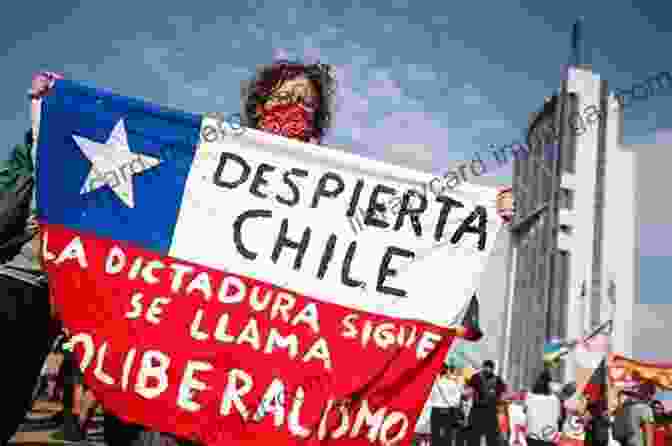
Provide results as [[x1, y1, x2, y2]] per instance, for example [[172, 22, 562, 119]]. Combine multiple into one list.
[[502, 66, 639, 388]]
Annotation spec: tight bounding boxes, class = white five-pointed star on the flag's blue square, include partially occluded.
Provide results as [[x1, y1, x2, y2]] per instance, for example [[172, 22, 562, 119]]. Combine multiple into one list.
[[72, 119, 162, 208]]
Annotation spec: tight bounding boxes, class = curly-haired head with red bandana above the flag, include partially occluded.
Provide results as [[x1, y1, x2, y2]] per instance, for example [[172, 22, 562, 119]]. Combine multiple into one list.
[[242, 60, 335, 144]]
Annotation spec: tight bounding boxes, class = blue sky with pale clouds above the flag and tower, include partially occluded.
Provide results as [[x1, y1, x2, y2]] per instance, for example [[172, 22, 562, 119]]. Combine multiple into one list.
[[0, 0, 672, 372]]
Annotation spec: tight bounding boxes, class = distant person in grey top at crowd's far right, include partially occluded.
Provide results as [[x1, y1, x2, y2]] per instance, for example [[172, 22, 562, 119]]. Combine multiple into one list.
[[613, 390, 655, 446]]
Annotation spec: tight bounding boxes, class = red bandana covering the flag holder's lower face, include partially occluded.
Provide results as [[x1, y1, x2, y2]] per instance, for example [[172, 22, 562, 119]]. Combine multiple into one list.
[[258, 104, 317, 142]]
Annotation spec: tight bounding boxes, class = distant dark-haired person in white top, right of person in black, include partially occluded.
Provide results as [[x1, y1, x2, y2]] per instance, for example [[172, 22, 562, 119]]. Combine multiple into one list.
[[525, 370, 562, 446]]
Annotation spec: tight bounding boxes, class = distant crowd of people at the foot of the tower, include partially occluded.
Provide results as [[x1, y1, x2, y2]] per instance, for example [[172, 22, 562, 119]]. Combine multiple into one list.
[[417, 360, 672, 446]]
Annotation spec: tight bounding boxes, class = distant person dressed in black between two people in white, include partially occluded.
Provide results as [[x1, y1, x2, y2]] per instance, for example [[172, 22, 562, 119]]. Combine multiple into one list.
[[466, 360, 506, 446]]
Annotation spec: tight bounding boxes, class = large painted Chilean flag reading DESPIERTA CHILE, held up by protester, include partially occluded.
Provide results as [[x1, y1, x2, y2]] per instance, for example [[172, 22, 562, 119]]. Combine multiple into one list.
[[36, 79, 501, 446]]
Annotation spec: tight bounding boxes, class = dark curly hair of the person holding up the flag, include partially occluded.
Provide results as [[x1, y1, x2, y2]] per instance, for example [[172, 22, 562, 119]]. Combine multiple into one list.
[[241, 60, 335, 139]]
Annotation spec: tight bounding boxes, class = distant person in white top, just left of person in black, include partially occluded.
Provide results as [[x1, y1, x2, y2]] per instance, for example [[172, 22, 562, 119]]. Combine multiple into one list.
[[430, 364, 464, 446]]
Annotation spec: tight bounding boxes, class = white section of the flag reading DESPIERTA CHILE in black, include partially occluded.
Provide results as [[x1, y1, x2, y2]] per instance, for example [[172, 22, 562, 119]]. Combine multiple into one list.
[[170, 118, 501, 326]]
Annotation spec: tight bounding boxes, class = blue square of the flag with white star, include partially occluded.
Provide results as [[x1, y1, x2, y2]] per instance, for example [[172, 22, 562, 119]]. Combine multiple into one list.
[[37, 80, 201, 253]]
